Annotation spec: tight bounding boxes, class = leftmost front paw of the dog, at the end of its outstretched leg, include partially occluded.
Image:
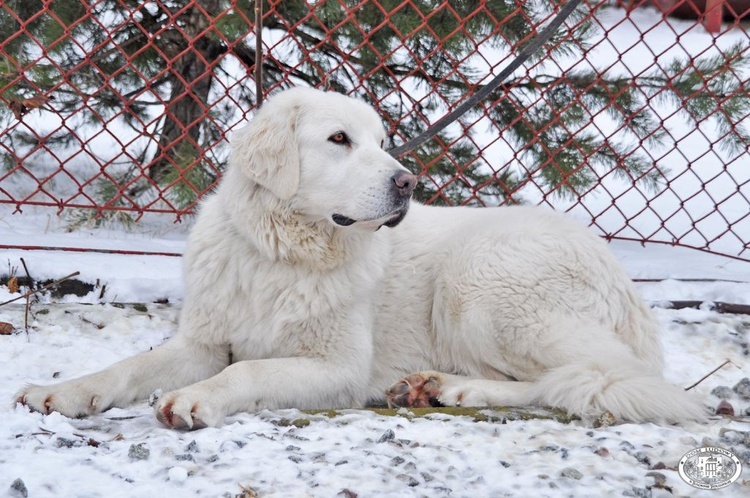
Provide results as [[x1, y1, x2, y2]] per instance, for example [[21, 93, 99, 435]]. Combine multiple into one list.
[[15, 381, 109, 418]]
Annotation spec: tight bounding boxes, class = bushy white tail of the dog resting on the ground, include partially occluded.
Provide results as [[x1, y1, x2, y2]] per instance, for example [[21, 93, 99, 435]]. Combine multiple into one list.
[[529, 362, 707, 422]]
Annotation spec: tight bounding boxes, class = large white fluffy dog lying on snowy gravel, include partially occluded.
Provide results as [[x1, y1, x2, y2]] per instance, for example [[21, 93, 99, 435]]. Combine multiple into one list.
[[17, 89, 704, 428]]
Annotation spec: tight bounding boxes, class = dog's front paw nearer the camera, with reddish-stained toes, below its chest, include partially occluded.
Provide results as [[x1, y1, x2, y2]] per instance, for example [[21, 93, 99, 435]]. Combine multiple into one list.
[[154, 388, 224, 430]]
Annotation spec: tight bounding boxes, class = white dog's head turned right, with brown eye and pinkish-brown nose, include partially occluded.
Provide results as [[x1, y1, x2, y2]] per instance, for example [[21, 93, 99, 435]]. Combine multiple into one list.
[[231, 88, 416, 229]]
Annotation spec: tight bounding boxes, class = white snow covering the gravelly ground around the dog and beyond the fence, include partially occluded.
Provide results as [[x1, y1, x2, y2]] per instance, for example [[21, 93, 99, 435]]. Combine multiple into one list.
[[0, 4, 750, 498]]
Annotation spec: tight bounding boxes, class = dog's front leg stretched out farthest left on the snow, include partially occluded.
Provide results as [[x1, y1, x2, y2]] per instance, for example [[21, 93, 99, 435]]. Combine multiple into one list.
[[15, 336, 229, 417]]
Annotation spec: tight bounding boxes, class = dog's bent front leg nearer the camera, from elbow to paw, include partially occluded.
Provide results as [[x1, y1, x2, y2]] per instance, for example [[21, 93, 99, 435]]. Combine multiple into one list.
[[155, 358, 368, 429]]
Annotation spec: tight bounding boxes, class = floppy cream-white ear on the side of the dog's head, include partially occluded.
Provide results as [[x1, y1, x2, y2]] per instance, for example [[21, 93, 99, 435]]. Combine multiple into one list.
[[231, 99, 300, 199]]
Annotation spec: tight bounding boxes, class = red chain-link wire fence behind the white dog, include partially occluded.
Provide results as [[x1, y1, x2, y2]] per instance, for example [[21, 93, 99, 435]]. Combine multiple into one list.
[[0, 0, 750, 261]]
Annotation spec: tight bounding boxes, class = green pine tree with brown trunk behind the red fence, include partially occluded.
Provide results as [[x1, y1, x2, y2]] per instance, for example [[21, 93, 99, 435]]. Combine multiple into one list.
[[0, 0, 750, 220]]
